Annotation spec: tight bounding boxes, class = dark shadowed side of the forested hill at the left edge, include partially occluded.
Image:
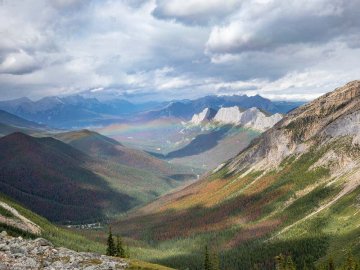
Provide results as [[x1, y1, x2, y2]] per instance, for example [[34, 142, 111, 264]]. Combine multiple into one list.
[[0, 133, 135, 222]]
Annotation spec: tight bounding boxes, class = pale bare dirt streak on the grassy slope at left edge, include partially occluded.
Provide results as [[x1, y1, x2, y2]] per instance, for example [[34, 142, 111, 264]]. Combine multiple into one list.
[[0, 201, 41, 235]]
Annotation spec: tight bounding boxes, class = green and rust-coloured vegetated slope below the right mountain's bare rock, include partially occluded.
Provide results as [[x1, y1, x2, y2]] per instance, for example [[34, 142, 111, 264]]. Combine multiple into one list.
[[114, 138, 360, 269]]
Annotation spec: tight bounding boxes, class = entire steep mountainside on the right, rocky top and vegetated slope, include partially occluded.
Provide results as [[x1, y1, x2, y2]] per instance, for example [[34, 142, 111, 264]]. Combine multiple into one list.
[[116, 81, 360, 269]]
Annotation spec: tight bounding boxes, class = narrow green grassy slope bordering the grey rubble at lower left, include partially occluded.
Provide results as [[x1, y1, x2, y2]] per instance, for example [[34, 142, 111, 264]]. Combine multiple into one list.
[[0, 194, 171, 270]]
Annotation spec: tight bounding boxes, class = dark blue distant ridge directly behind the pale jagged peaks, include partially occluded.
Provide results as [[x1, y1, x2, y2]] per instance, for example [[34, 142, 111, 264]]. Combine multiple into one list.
[[142, 95, 302, 121]]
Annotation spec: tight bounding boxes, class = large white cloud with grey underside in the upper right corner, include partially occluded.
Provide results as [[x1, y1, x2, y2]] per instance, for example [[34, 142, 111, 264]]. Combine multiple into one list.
[[206, 0, 360, 54]]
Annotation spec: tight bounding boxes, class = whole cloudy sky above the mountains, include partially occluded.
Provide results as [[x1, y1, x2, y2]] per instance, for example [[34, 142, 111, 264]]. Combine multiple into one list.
[[0, 0, 360, 100]]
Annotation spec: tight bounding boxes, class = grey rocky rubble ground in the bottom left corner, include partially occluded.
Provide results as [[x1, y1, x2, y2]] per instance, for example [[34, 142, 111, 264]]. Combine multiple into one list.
[[0, 231, 128, 270]]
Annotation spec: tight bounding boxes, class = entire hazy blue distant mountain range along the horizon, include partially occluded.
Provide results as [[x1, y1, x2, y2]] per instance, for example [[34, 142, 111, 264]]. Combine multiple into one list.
[[0, 94, 301, 129]]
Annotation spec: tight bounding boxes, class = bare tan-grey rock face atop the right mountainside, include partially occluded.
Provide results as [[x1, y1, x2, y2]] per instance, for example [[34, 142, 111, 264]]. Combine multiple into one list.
[[226, 81, 360, 171]]
